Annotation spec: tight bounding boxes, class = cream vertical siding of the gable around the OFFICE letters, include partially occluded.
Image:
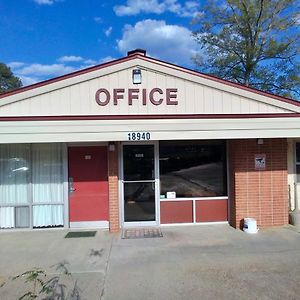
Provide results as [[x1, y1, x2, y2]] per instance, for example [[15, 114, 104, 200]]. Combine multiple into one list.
[[0, 60, 300, 116]]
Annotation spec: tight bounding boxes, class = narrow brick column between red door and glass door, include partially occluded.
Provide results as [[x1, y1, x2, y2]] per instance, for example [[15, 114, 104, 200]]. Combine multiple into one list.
[[108, 144, 120, 233]]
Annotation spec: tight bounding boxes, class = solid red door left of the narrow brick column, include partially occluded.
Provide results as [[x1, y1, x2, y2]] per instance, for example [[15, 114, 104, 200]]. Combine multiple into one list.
[[68, 146, 108, 222]]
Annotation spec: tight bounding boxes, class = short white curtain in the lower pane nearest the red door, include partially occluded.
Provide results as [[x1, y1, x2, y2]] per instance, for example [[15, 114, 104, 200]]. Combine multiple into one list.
[[33, 205, 64, 227]]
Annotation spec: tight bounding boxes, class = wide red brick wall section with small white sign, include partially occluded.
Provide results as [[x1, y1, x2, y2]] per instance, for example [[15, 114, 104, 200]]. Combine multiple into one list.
[[229, 139, 288, 228]]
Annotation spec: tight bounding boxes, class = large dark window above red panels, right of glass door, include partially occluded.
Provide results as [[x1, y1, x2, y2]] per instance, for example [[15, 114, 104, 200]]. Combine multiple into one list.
[[159, 141, 227, 198]]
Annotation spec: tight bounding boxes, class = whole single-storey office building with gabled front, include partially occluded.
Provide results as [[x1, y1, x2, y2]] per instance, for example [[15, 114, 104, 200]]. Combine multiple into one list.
[[0, 50, 300, 232]]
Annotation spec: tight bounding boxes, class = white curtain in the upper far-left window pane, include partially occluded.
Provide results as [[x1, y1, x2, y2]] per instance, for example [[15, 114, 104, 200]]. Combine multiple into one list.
[[0, 144, 30, 205]]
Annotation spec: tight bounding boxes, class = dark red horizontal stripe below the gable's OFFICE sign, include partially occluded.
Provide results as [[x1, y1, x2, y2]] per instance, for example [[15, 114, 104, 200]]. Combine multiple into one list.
[[0, 113, 300, 122]]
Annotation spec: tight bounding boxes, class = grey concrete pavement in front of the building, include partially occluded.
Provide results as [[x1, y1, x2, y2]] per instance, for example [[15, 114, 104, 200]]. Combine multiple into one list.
[[0, 225, 300, 300]]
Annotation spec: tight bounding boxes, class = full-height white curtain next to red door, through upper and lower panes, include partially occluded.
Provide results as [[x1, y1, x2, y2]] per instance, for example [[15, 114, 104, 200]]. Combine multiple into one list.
[[32, 144, 64, 227]]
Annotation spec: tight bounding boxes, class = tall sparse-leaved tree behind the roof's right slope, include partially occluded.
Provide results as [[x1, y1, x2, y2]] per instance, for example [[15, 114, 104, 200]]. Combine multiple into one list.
[[193, 0, 300, 98]]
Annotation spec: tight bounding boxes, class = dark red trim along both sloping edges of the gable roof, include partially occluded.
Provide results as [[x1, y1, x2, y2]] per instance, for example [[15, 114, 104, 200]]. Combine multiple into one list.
[[0, 53, 300, 106]]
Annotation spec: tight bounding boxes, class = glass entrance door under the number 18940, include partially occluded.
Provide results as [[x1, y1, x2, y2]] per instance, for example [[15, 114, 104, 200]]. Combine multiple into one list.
[[123, 144, 156, 223]]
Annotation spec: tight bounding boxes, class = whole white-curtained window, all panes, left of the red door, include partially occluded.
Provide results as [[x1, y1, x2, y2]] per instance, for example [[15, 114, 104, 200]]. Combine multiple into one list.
[[0, 144, 64, 228]]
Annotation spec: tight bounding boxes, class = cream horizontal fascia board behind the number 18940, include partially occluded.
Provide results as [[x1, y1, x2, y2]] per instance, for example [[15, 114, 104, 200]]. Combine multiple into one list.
[[0, 117, 300, 143]]
